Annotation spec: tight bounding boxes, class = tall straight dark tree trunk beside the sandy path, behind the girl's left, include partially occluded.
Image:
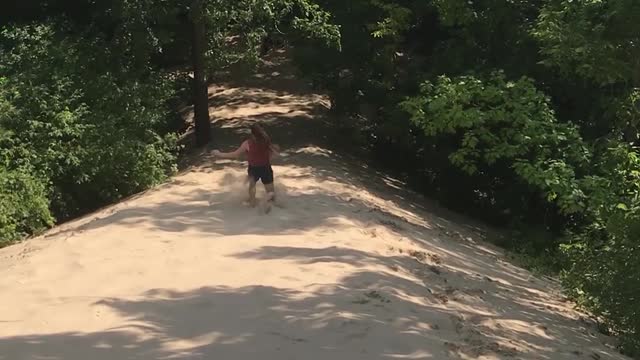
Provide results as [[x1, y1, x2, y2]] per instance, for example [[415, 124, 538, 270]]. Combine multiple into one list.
[[191, 0, 211, 146]]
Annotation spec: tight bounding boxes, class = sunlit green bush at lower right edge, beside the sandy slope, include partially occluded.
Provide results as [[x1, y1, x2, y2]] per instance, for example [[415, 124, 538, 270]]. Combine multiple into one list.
[[562, 145, 640, 356]]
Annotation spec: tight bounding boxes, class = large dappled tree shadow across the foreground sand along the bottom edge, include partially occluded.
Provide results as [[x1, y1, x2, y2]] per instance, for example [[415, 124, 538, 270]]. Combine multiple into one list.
[[0, 266, 614, 360]]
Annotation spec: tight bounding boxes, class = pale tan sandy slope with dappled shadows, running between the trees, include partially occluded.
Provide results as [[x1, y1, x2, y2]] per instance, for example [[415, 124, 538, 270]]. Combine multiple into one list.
[[0, 51, 623, 360]]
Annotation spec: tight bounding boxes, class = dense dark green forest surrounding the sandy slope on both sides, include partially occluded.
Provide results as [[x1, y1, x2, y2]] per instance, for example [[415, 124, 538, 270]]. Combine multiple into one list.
[[0, 0, 640, 357]]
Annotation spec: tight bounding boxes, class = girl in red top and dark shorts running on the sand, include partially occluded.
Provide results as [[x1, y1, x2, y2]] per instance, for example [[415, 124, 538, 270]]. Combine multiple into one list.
[[213, 123, 279, 213]]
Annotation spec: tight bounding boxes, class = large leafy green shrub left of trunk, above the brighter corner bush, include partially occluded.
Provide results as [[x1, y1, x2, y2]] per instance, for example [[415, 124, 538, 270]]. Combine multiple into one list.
[[0, 25, 175, 219]]
